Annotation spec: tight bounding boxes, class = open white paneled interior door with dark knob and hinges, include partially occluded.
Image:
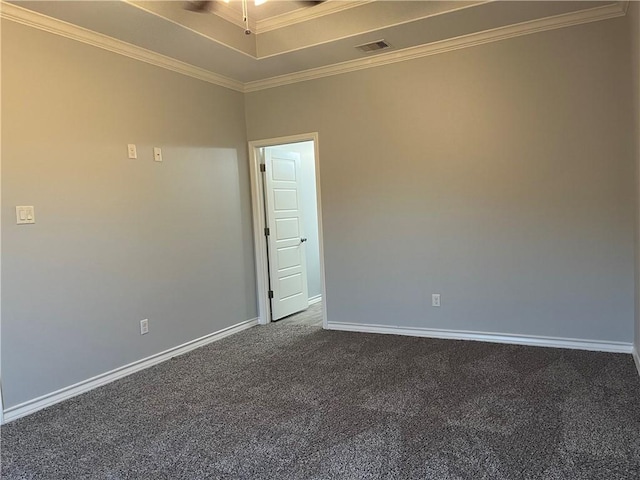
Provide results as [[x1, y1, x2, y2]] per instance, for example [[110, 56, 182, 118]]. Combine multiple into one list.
[[265, 148, 309, 320]]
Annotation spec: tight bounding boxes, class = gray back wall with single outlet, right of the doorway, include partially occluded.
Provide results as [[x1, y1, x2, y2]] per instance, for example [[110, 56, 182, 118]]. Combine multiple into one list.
[[245, 18, 636, 342]]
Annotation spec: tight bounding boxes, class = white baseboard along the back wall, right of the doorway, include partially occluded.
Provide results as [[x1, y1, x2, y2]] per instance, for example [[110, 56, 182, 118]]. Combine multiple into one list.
[[327, 322, 638, 354]]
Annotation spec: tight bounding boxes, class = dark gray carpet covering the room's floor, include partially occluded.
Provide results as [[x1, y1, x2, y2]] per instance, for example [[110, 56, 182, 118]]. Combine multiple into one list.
[[2, 324, 640, 480]]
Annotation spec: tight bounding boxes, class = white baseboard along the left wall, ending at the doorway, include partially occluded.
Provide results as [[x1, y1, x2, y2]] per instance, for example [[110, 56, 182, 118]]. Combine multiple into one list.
[[2, 318, 258, 422]]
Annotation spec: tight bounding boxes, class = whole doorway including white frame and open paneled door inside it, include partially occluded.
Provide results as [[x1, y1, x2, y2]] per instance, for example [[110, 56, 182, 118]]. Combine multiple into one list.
[[249, 133, 327, 328]]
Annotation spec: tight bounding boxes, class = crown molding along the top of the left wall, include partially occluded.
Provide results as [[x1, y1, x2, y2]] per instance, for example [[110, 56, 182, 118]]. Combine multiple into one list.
[[0, 2, 244, 92]]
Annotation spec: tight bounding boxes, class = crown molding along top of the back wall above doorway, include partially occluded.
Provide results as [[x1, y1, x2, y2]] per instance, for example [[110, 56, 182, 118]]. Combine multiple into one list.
[[245, 1, 628, 92]]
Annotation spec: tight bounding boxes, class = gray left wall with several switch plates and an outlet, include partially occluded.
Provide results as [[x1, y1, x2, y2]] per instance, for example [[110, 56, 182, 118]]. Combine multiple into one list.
[[2, 21, 256, 408]]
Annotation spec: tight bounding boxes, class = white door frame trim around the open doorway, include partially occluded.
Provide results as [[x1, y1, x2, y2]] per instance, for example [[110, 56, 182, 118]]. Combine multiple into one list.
[[249, 132, 327, 328]]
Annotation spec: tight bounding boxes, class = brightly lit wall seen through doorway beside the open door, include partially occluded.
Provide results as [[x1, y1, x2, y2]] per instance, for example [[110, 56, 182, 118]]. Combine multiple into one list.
[[280, 142, 322, 298]]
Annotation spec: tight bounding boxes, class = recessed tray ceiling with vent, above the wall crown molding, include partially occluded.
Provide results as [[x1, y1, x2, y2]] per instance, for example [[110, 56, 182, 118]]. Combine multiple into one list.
[[3, 0, 625, 85]]
